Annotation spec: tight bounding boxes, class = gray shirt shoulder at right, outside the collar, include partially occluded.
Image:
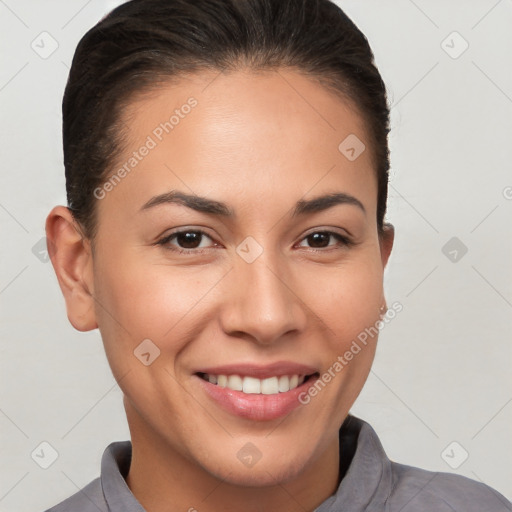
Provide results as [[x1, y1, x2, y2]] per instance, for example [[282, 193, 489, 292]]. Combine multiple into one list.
[[387, 462, 512, 512]]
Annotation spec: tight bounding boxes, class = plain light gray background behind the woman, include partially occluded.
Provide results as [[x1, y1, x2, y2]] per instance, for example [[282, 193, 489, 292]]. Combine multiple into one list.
[[0, 0, 512, 512]]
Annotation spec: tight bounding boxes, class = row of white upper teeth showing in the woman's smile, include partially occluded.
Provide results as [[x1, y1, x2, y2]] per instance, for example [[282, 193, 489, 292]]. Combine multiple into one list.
[[203, 374, 306, 395]]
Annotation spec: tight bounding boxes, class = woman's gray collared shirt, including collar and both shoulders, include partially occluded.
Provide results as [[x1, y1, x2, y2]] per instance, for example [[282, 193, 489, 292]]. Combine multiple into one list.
[[42, 414, 512, 512]]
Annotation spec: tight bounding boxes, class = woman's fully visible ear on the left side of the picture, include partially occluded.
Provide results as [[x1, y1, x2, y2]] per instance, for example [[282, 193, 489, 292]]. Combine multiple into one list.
[[46, 206, 98, 331]]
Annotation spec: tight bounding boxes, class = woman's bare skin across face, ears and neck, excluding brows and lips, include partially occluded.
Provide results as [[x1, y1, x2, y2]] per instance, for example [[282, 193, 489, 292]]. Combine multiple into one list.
[[46, 69, 393, 512]]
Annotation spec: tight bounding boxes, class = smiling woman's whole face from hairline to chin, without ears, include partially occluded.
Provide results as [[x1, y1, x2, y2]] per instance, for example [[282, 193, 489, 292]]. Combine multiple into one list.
[[55, 70, 390, 485]]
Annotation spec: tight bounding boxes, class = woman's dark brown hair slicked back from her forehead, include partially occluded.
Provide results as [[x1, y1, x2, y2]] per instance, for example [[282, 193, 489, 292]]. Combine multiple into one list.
[[62, 0, 389, 238]]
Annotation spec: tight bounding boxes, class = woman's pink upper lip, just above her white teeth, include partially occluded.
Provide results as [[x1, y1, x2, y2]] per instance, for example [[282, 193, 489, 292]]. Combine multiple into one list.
[[196, 361, 318, 379]]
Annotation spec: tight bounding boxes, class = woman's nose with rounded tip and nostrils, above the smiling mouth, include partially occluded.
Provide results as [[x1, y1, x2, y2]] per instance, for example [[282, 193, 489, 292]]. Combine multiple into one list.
[[220, 252, 307, 345]]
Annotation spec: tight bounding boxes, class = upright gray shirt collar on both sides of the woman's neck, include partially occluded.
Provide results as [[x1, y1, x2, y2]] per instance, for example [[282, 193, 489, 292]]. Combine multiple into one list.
[[101, 414, 392, 512]]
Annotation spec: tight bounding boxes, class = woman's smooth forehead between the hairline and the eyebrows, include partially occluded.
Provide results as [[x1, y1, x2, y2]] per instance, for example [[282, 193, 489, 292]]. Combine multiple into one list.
[[99, 69, 376, 220]]
